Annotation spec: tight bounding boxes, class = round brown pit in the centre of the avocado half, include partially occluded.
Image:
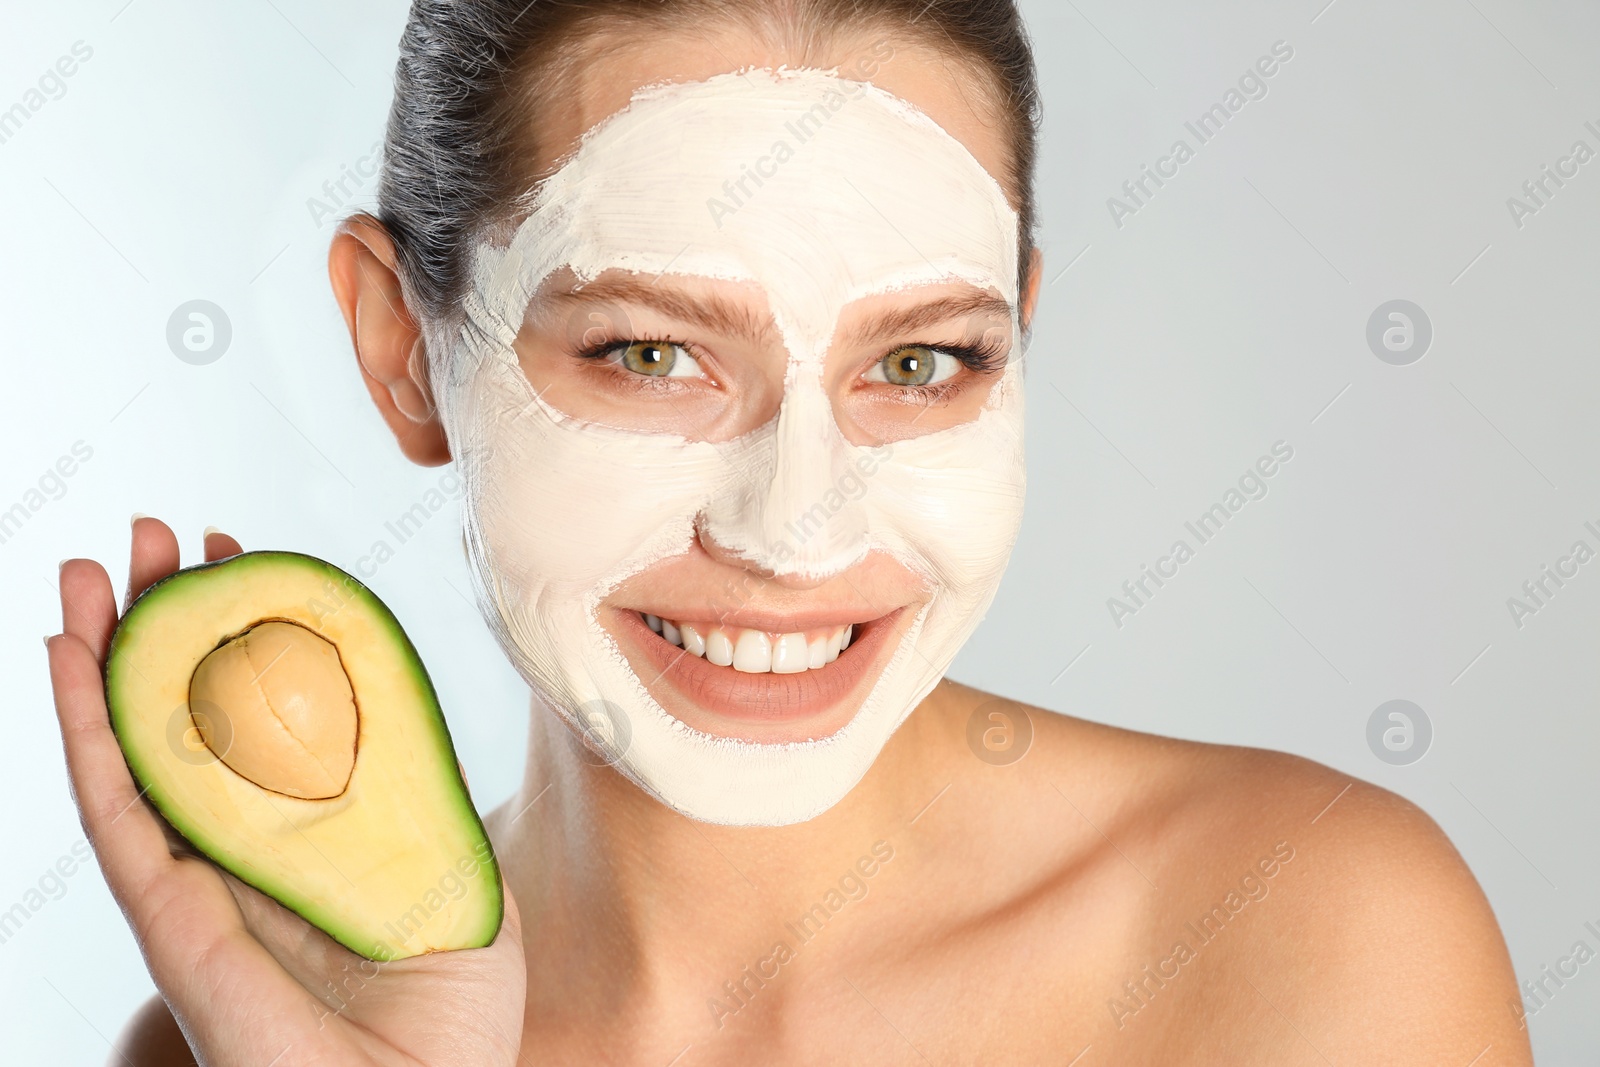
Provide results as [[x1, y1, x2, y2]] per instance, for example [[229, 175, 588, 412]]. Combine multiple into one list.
[[189, 621, 358, 800]]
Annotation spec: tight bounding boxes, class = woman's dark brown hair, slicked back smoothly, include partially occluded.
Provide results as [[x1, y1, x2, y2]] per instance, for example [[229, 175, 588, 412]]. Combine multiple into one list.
[[378, 0, 1040, 322]]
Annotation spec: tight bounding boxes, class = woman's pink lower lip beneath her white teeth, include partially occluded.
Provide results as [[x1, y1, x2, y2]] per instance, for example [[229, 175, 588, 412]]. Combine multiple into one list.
[[616, 608, 906, 741]]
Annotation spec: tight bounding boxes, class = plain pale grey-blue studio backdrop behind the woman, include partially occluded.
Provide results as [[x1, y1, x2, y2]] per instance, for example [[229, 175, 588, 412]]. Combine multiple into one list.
[[0, 0, 1600, 1064]]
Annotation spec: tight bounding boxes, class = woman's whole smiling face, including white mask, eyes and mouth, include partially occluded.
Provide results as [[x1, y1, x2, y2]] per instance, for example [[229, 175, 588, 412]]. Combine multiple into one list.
[[446, 27, 1027, 822]]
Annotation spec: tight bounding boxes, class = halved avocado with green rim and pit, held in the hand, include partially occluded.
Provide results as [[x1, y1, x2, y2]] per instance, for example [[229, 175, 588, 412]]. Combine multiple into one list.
[[106, 552, 504, 960]]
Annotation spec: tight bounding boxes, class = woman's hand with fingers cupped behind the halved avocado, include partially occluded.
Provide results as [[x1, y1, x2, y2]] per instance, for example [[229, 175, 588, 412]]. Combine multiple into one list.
[[46, 518, 526, 1067]]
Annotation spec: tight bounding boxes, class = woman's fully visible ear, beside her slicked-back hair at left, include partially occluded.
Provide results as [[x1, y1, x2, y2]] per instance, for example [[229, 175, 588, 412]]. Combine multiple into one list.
[[328, 214, 450, 467]]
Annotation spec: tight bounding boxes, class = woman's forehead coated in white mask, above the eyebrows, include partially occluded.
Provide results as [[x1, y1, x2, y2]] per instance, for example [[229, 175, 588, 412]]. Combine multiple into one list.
[[486, 69, 1018, 367]]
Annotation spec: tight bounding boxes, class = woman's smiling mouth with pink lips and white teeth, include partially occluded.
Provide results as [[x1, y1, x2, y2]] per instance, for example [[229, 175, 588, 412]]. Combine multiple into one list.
[[598, 605, 922, 744]]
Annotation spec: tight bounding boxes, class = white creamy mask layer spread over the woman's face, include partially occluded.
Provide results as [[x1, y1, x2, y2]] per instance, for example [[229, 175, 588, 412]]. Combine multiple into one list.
[[434, 70, 1024, 825]]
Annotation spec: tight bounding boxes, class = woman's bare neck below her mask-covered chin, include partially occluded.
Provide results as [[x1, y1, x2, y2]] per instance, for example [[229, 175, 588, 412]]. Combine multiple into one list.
[[493, 683, 950, 1019]]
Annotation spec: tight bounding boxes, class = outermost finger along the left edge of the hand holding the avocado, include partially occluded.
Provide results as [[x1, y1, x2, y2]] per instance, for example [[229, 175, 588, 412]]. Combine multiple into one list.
[[45, 633, 173, 925]]
